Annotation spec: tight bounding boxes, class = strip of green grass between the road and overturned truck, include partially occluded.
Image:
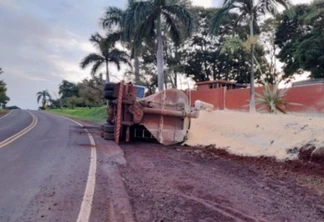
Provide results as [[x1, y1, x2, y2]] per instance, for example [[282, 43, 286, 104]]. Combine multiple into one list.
[[47, 106, 107, 122]]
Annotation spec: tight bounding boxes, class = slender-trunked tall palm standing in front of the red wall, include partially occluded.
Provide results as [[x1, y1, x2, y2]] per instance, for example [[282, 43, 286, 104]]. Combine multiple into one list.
[[210, 0, 291, 112]]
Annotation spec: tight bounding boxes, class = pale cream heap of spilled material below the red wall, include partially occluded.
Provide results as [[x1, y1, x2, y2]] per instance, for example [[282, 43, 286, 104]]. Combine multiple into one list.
[[185, 111, 324, 160]]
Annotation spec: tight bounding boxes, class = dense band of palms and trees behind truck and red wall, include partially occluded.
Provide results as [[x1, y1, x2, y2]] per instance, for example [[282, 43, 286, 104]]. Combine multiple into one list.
[[37, 0, 324, 114]]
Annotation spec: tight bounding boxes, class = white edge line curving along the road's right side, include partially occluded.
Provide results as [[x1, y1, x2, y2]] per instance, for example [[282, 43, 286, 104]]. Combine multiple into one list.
[[61, 116, 97, 222]]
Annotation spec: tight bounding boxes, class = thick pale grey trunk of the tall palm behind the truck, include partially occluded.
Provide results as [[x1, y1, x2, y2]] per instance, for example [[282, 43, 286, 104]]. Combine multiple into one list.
[[156, 15, 164, 91]]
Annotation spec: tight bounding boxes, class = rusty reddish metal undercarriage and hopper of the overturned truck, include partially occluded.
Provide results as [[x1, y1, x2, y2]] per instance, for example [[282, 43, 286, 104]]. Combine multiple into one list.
[[102, 81, 198, 145]]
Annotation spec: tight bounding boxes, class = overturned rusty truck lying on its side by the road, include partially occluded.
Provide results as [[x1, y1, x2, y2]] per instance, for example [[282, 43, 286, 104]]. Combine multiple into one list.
[[101, 81, 208, 145]]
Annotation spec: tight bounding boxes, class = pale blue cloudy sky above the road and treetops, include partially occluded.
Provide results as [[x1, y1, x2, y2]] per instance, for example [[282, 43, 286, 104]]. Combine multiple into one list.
[[0, 0, 309, 109]]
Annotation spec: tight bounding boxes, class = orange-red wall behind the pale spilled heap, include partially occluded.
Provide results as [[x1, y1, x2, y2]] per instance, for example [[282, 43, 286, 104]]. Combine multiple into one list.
[[187, 84, 324, 113]]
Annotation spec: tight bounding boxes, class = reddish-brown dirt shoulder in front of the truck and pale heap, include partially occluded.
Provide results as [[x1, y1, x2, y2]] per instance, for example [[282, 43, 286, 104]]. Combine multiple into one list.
[[121, 143, 324, 222]]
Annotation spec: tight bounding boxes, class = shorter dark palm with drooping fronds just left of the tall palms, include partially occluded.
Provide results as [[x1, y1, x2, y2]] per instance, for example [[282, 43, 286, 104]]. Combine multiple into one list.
[[80, 33, 130, 82]]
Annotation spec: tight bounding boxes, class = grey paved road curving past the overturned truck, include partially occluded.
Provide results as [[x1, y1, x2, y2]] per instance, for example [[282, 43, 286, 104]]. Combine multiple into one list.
[[0, 110, 132, 221]]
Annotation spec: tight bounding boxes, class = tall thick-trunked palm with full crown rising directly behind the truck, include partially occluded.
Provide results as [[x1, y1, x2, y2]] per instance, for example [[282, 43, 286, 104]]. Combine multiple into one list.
[[125, 0, 194, 91]]
